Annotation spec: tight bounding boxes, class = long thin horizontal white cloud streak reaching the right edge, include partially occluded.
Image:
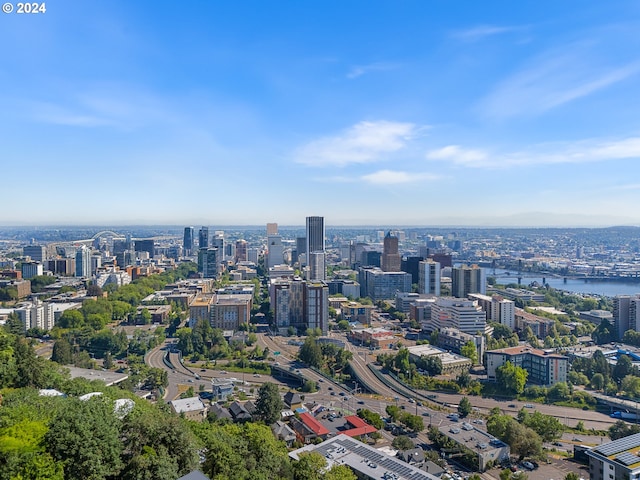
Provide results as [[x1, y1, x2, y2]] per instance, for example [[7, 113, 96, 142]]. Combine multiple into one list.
[[426, 137, 640, 168]]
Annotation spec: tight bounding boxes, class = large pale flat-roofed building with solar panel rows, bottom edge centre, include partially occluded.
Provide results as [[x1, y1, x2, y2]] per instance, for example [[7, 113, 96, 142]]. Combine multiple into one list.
[[289, 434, 438, 480]]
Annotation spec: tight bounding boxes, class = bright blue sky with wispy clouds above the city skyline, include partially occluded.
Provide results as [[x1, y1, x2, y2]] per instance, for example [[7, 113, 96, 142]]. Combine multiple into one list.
[[0, 0, 640, 226]]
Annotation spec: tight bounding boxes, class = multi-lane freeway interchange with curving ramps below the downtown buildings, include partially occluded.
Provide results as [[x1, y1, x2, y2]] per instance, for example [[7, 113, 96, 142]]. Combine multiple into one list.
[[145, 333, 615, 436]]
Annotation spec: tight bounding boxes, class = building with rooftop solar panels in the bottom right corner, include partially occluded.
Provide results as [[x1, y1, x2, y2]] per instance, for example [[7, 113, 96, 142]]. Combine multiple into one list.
[[585, 433, 640, 480]]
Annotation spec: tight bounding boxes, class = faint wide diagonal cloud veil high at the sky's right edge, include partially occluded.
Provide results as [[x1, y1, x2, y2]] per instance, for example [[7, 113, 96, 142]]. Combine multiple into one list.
[[479, 44, 640, 118]]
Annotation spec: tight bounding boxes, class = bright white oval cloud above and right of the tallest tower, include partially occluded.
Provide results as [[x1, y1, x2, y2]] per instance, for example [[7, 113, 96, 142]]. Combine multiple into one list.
[[295, 120, 418, 167]]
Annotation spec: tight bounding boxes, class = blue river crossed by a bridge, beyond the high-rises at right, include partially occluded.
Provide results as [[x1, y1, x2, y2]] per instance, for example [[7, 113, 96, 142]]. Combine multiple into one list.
[[486, 268, 640, 297]]
